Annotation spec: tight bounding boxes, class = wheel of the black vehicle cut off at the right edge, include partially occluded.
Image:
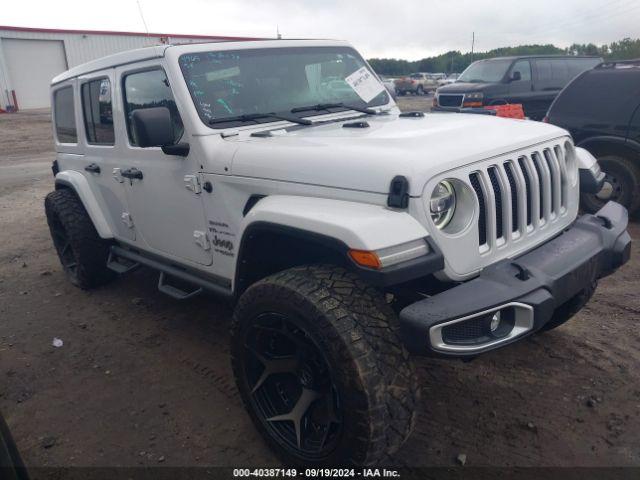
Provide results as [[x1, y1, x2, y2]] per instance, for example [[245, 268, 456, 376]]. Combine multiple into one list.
[[580, 155, 640, 214]]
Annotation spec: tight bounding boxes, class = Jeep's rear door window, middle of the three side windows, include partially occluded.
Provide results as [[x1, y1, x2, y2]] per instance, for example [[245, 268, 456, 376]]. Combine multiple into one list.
[[81, 78, 114, 145]]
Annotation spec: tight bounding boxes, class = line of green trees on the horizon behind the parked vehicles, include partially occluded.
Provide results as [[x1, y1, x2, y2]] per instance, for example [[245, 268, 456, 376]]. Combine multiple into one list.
[[369, 38, 640, 77]]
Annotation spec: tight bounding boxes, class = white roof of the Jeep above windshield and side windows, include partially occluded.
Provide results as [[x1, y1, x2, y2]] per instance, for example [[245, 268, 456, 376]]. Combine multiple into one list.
[[51, 39, 350, 85]]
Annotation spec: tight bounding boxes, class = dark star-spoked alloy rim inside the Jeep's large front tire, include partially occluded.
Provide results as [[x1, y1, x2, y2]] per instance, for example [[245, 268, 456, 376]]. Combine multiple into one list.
[[244, 313, 343, 460]]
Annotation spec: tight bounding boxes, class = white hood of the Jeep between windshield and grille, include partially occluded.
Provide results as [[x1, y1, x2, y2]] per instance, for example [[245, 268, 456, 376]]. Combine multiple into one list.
[[228, 113, 567, 196]]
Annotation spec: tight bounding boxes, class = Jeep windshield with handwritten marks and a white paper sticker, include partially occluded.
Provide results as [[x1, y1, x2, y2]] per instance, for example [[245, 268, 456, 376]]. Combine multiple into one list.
[[179, 47, 389, 128]]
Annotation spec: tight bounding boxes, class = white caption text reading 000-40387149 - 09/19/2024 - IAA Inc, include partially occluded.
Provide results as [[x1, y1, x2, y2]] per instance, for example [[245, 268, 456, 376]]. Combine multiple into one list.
[[233, 468, 400, 478]]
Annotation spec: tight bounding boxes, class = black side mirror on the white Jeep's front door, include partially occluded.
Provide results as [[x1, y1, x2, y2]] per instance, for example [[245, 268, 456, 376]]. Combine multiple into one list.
[[131, 107, 189, 157]]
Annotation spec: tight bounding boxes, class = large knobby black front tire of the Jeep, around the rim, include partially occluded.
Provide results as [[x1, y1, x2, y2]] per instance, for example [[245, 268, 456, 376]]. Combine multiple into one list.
[[231, 266, 420, 465]]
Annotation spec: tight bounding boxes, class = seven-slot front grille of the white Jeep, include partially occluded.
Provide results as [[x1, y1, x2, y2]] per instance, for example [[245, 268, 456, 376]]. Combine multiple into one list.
[[469, 145, 569, 252]]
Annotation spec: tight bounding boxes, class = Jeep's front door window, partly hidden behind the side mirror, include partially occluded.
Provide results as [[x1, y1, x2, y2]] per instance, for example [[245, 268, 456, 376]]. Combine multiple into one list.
[[123, 69, 184, 146]]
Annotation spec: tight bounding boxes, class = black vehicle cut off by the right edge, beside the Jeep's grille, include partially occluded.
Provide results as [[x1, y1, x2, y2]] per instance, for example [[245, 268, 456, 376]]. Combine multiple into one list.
[[545, 59, 640, 213]]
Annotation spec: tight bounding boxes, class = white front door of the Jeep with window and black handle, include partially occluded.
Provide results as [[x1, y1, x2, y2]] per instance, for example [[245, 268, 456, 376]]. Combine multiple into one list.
[[117, 63, 212, 265]]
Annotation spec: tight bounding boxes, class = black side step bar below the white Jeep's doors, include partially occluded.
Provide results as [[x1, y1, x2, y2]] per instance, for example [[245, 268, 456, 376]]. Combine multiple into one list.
[[107, 246, 233, 300]]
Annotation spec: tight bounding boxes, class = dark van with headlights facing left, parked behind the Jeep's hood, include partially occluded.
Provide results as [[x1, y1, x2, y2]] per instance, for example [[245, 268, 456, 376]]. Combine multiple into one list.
[[434, 55, 602, 120]]
